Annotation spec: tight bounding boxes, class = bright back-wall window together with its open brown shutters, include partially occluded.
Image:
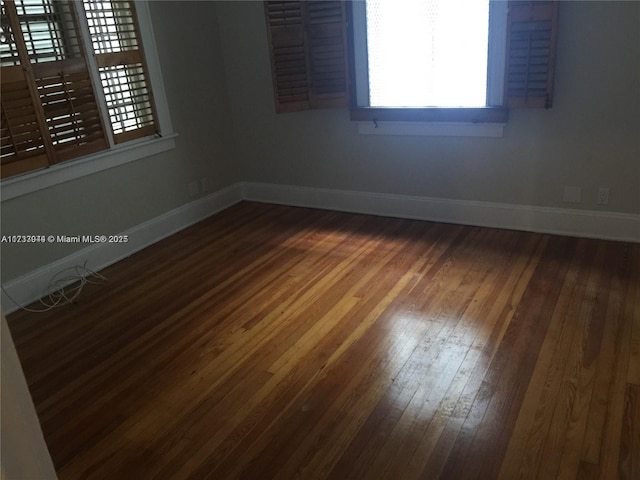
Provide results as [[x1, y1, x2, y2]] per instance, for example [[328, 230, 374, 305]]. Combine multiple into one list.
[[265, 0, 558, 123]]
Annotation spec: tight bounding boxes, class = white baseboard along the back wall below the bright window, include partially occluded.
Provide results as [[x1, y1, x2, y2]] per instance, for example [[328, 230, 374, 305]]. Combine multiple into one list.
[[242, 183, 640, 242]]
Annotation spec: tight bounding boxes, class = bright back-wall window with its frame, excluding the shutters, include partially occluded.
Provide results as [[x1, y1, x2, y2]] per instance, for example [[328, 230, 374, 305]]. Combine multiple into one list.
[[352, 0, 507, 123]]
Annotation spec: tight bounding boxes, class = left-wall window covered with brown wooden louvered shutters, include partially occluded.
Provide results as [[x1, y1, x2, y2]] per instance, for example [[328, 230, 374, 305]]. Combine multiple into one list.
[[0, 0, 168, 180]]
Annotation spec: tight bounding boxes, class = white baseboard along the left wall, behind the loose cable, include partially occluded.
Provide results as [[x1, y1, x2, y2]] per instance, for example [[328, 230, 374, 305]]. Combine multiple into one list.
[[2, 184, 242, 314]]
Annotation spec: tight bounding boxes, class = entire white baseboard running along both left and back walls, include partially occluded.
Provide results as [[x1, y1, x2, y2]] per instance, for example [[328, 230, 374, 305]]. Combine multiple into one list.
[[2, 182, 640, 314]]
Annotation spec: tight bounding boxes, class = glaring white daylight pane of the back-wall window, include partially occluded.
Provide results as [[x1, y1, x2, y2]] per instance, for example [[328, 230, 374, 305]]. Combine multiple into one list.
[[366, 0, 489, 107]]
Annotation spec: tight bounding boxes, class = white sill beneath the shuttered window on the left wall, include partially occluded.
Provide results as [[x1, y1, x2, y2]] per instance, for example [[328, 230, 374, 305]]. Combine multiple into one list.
[[0, 133, 178, 202]]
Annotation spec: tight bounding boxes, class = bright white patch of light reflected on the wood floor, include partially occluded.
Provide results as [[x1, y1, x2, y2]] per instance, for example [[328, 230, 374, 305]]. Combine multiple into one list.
[[381, 311, 489, 426]]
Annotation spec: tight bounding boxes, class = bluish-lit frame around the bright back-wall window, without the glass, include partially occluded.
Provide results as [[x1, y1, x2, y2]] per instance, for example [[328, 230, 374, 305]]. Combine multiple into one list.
[[347, 0, 509, 125]]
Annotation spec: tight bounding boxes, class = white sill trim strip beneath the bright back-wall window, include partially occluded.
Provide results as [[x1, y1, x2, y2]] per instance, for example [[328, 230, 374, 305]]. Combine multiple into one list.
[[358, 122, 505, 138]]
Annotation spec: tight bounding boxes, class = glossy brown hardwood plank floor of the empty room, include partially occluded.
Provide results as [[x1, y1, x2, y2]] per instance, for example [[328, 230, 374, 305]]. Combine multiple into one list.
[[9, 203, 640, 480]]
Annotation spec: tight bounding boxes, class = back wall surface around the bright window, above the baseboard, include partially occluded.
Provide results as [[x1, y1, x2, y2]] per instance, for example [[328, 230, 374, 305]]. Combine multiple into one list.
[[218, 1, 640, 214]]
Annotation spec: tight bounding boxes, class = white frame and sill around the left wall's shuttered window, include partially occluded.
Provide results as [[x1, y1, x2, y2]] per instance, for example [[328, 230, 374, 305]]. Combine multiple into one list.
[[0, 0, 177, 201]]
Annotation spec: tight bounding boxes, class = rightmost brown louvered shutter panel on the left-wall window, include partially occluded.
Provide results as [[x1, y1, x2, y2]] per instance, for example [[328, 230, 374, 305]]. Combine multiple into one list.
[[83, 0, 158, 143]]
